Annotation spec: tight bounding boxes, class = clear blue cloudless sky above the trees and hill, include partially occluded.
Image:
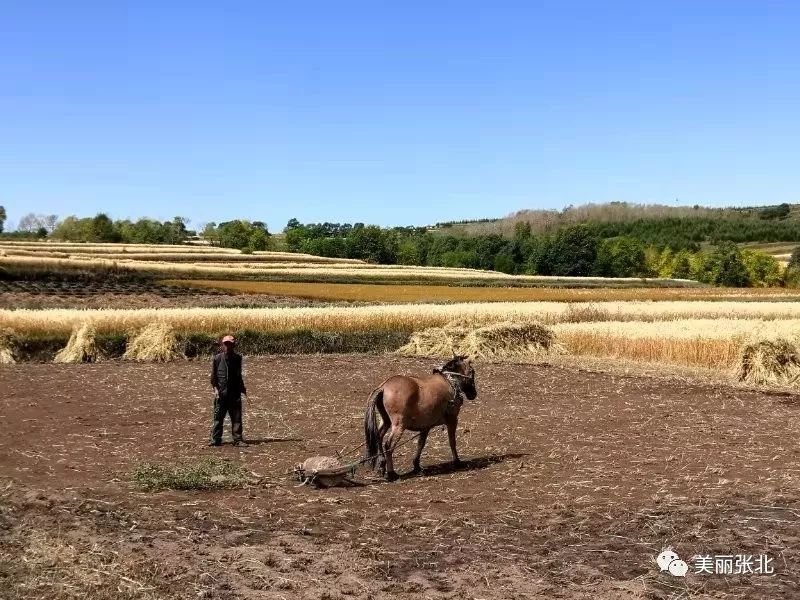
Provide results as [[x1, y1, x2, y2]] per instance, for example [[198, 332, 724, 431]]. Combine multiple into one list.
[[0, 0, 800, 231]]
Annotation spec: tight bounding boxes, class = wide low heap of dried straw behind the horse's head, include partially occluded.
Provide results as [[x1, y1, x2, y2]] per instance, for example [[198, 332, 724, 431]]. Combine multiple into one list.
[[398, 321, 561, 359]]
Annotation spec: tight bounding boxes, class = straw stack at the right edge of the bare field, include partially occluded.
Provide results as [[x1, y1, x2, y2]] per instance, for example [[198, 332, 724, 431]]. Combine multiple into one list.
[[736, 338, 800, 385]]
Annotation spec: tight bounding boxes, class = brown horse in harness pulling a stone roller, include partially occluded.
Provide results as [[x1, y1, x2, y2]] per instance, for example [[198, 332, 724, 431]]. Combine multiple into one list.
[[364, 355, 478, 481]]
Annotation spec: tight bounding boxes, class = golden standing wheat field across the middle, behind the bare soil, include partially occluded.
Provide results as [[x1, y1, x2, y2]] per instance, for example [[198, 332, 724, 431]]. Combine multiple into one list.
[[0, 301, 800, 378]]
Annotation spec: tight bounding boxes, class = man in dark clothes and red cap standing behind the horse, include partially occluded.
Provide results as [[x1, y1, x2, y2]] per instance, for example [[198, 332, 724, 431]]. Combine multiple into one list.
[[208, 335, 247, 447]]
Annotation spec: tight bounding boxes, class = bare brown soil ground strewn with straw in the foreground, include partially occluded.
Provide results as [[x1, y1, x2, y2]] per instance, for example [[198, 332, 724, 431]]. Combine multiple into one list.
[[0, 356, 800, 600]]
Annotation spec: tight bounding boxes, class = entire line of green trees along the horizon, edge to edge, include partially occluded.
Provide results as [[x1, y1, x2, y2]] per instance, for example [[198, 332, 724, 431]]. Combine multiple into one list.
[[0, 205, 800, 286]]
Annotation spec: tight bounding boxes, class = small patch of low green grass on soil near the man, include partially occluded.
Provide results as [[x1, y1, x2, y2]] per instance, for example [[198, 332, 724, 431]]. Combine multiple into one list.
[[132, 458, 247, 492]]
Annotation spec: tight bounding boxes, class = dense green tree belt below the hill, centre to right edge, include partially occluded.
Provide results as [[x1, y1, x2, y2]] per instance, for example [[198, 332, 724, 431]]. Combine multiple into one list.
[[284, 219, 800, 286]]
